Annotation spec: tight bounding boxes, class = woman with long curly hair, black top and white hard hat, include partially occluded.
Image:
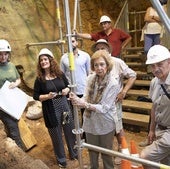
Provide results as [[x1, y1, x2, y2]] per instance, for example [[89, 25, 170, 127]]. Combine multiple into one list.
[[33, 48, 77, 168]]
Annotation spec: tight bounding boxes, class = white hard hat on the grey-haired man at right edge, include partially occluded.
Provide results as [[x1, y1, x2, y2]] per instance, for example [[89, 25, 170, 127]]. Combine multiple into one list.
[[146, 45, 170, 65]]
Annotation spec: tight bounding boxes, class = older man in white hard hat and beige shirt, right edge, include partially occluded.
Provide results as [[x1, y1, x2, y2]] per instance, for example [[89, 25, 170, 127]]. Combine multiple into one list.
[[141, 45, 170, 169]]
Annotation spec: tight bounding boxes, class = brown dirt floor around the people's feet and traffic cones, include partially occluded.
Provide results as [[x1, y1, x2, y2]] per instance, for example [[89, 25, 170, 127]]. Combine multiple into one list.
[[23, 112, 147, 169]]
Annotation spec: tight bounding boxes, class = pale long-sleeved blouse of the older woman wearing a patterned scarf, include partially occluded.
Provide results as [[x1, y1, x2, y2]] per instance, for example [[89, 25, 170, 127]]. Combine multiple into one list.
[[83, 73, 120, 135]]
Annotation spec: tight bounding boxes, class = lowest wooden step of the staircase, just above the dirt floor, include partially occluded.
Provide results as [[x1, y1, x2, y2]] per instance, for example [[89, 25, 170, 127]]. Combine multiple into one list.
[[122, 112, 149, 128]]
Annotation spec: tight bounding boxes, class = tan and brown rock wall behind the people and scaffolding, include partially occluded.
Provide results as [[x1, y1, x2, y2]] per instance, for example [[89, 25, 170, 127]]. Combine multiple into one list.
[[0, 0, 148, 90]]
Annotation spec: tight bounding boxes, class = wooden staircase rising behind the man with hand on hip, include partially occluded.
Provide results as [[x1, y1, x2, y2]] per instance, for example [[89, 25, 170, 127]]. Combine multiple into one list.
[[122, 47, 153, 129]]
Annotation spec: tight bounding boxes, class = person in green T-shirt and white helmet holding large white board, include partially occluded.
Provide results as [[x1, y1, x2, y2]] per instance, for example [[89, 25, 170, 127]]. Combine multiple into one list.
[[0, 39, 24, 149]]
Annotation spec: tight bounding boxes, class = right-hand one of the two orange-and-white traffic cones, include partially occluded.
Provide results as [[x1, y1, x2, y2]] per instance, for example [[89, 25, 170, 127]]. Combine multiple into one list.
[[130, 140, 143, 169]]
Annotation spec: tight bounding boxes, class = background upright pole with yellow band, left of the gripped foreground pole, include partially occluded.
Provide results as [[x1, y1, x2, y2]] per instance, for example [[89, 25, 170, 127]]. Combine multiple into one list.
[[56, 0, 64, 54]]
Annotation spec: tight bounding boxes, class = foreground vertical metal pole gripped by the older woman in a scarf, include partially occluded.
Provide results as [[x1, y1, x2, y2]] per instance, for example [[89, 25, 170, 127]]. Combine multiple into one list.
[[64, 0, 83, 168]]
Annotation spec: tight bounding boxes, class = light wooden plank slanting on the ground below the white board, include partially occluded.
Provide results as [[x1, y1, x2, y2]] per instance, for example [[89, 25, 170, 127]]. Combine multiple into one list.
[[18, 118, 37, 151]]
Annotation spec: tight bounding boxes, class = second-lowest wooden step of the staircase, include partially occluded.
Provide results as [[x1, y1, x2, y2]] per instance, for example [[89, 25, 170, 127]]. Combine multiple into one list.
[[122, 99, 152, 111]]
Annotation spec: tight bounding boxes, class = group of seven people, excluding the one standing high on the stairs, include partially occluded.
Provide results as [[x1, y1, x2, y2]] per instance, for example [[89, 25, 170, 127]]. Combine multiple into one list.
[[0, 1, 170, 169]]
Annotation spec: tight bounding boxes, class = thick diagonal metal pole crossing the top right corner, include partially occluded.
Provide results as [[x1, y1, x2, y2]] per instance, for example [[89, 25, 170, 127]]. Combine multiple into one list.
[[150, 0, 170, 33]]
